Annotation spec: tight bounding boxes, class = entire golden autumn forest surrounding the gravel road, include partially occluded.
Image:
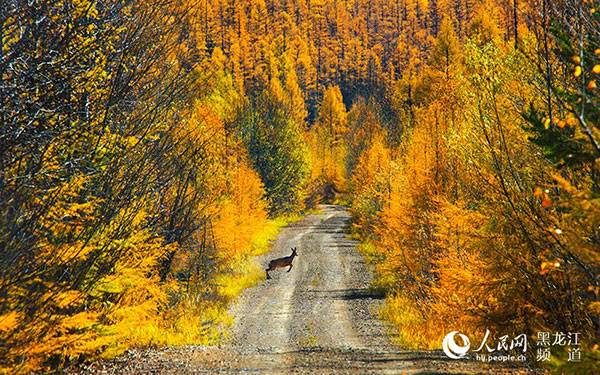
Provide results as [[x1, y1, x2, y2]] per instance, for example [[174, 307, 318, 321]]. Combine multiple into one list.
[[0, 0, 600, 373]]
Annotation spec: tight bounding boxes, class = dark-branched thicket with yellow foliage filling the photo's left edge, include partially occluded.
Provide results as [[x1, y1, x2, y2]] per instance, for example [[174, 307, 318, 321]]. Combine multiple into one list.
[[0, 0, 198, 372]]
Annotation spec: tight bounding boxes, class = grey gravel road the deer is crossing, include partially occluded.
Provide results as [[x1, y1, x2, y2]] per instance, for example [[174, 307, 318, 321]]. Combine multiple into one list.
[[72, 205, 536, 374]]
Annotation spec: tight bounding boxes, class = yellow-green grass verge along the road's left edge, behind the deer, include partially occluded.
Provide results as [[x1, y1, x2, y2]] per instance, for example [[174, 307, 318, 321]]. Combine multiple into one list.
[[69, 214, 304, 371]]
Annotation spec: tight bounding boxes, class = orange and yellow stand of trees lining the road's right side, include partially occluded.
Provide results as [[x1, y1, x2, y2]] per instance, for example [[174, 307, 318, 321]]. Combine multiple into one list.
[[352, 2, 600, 373]]
